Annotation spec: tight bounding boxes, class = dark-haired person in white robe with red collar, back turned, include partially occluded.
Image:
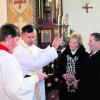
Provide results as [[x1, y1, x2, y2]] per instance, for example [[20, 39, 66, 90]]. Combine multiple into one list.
[[0, 24, 46, 100]]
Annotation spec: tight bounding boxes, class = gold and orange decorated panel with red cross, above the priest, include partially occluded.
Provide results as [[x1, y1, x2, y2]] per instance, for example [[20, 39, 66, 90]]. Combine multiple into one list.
[[7, 0, 35, 28]]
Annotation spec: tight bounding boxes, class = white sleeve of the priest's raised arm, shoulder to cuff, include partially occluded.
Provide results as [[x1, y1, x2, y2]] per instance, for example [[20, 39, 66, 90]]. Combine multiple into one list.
[[13, 46, 58, 71]]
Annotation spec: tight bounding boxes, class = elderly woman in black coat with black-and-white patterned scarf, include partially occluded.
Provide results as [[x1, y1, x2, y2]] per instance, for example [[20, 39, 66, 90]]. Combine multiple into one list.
[[57, 32, 88, 100]]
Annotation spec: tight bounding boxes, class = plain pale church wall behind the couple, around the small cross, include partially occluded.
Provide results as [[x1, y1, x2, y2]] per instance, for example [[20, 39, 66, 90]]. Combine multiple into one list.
[[63, 0, 100, 51]]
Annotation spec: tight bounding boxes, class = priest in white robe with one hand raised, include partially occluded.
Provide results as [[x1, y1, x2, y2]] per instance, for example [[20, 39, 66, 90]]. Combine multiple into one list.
[[13, 25, 61, 100]]
